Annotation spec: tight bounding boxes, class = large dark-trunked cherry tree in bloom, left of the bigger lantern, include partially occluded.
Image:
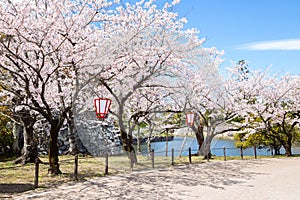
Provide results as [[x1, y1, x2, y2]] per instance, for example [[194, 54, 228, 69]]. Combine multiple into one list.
[[0, 0, 116, 174]]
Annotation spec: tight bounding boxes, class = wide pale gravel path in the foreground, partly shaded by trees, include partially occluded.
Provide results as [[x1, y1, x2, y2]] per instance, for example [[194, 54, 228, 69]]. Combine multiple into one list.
[[9, 158, 300, 200]]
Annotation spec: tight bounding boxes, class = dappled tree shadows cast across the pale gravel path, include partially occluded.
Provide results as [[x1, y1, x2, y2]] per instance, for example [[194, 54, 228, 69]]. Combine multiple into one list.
[[10, 160, 268, 200]]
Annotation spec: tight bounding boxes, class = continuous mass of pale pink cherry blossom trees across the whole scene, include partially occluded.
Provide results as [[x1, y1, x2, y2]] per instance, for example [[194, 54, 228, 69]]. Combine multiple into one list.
[[0, 0, 300, 174]]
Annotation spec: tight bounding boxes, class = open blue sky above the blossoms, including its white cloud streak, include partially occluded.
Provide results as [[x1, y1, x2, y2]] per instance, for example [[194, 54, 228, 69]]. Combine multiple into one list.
[[169, 0, 300, 75]]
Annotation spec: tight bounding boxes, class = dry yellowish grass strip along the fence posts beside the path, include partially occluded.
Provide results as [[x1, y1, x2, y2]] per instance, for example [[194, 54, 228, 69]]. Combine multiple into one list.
[[0, 152, 299, 199]]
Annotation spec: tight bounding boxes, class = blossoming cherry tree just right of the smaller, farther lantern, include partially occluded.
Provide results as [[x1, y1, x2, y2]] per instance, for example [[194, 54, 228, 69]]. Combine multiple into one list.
[[172, 52, 236, 158]]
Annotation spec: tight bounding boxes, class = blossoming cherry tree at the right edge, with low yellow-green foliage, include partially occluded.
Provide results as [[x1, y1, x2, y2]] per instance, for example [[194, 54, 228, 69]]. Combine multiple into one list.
[[214, 61, 299, 156]]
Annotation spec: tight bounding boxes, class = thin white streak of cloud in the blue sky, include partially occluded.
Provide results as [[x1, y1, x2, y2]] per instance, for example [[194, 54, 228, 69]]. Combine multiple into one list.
[[238, 39, 300, 50]]
